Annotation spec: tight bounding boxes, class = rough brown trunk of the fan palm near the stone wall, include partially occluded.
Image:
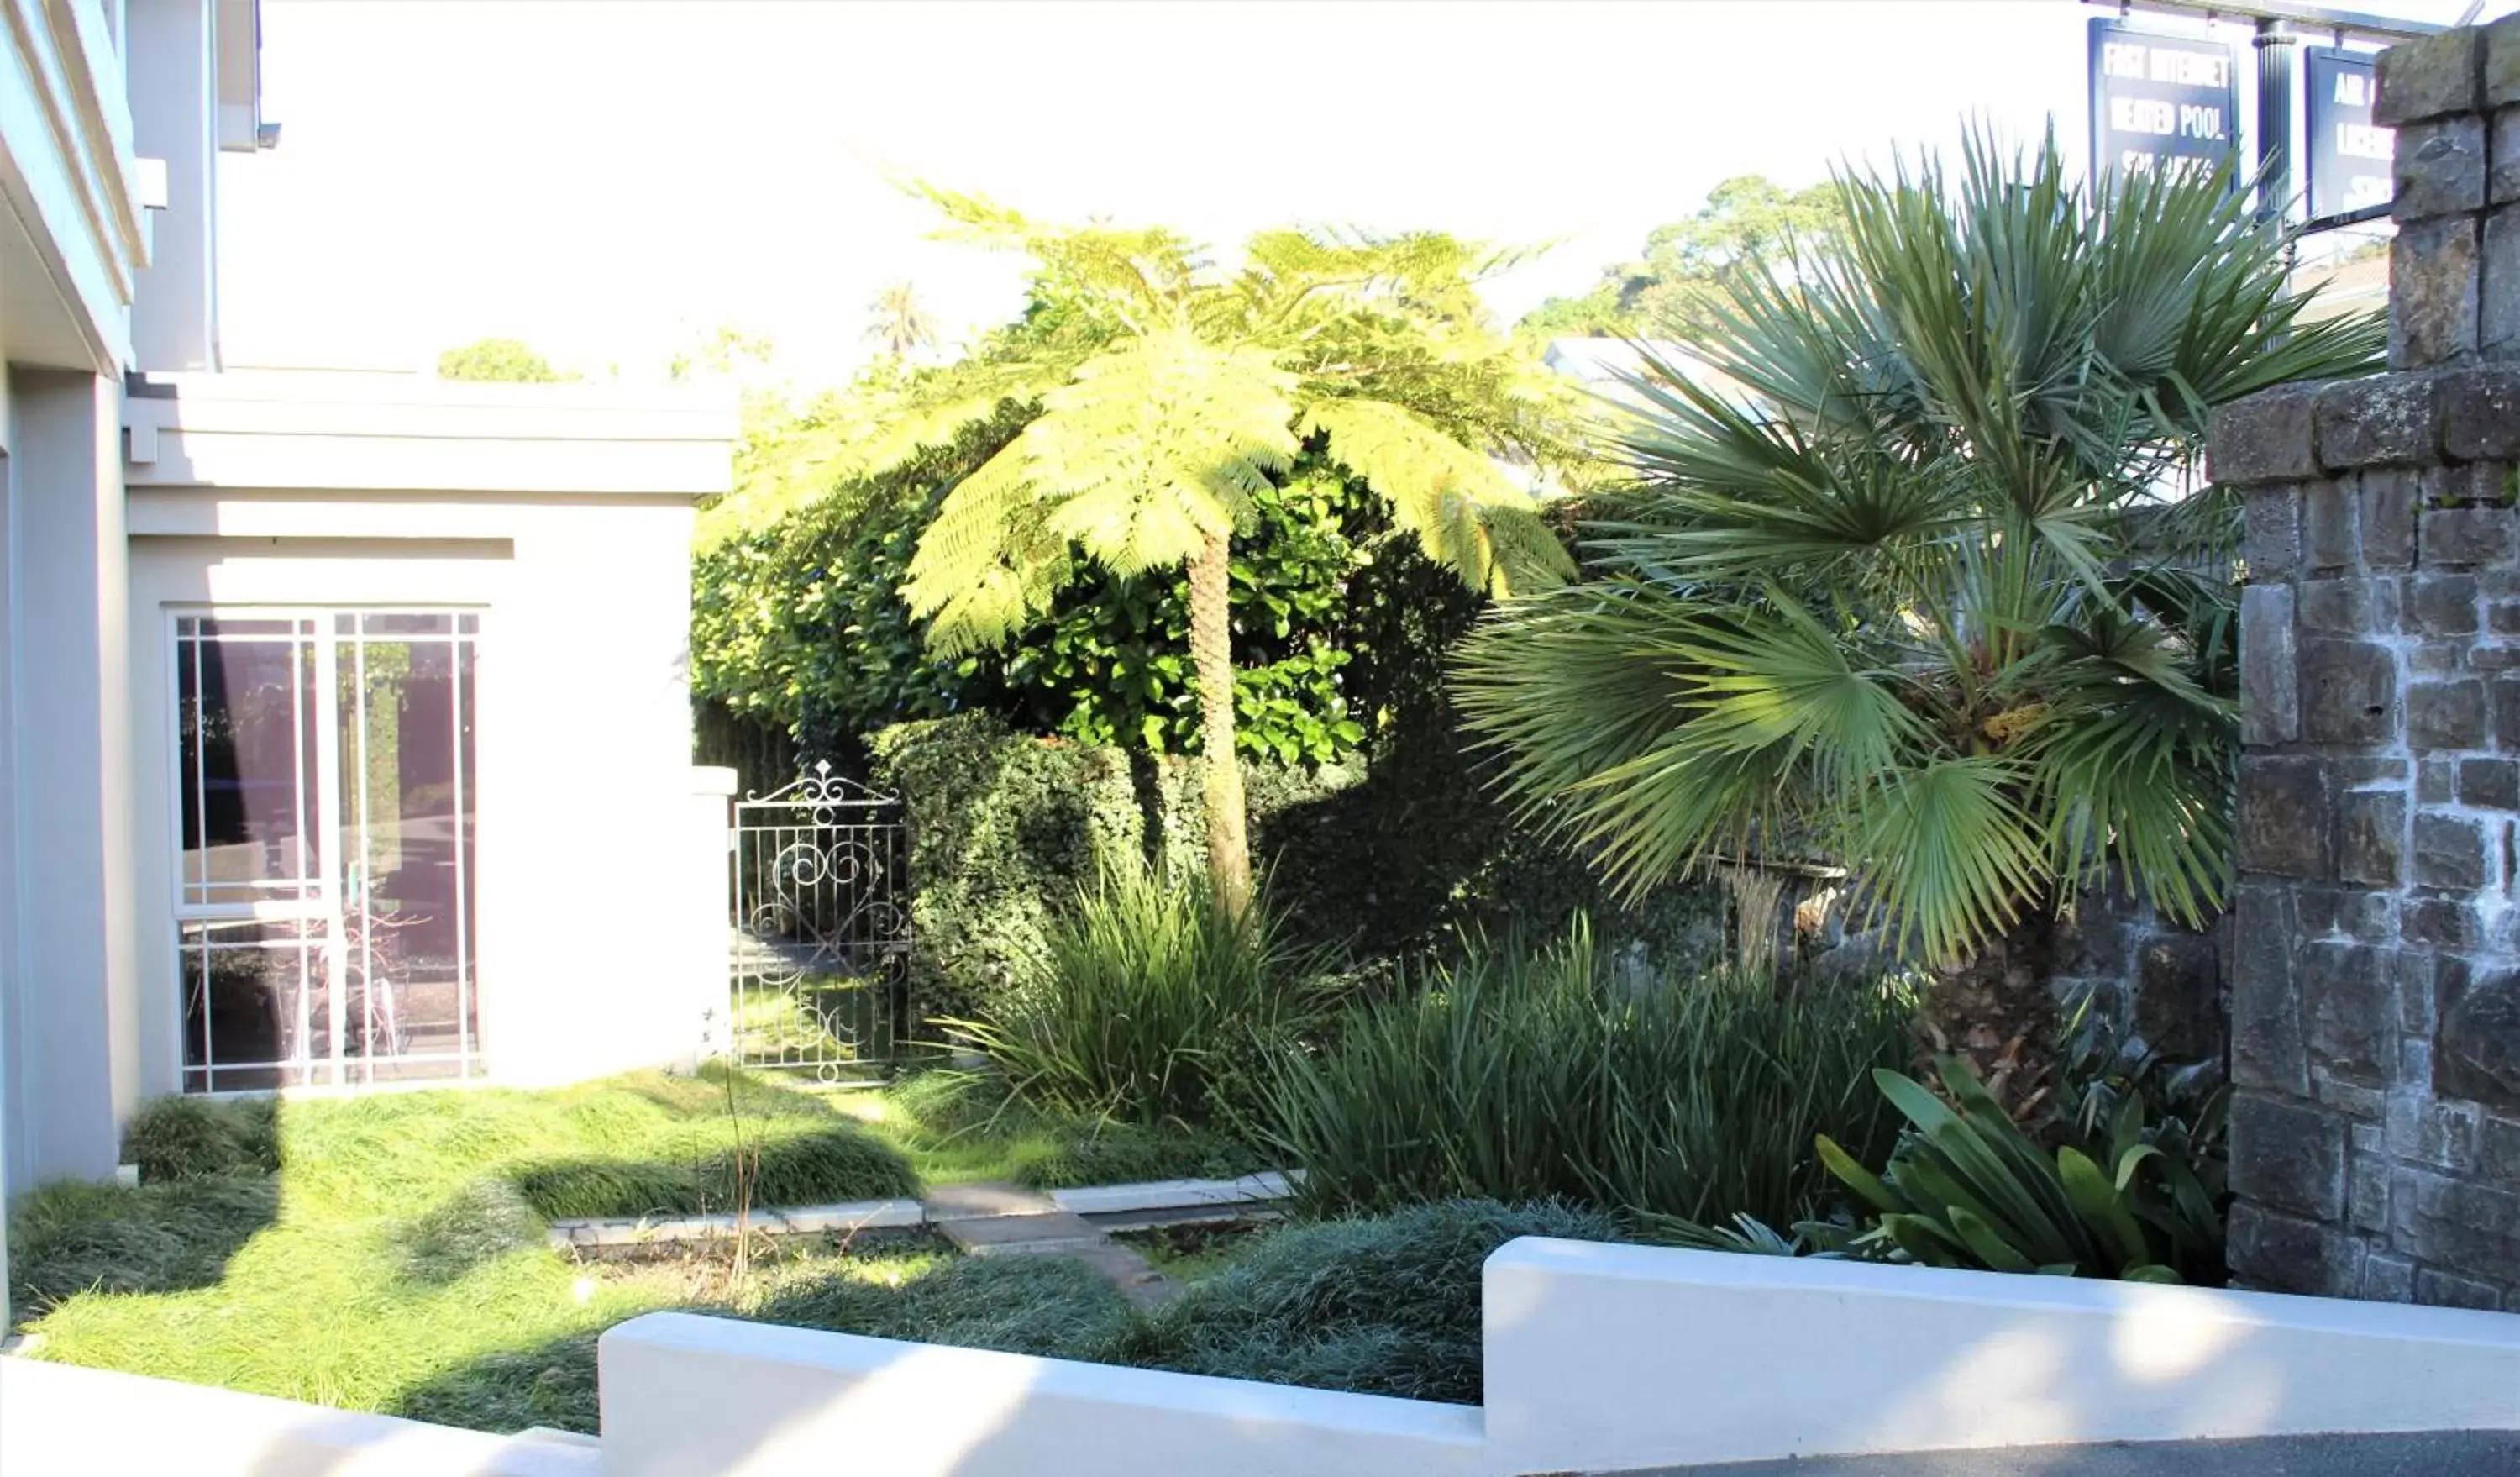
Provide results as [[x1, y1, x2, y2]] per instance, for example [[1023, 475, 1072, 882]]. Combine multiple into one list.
[[1923, 907, 2059, 1127]]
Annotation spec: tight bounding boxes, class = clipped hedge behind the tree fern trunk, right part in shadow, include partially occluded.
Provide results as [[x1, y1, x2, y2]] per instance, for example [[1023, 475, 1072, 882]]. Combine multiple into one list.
[[869, 713, 1724, 1021]]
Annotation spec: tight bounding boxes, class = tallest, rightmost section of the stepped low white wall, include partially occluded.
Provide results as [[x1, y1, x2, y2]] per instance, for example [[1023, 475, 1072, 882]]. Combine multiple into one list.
[[1484, 1240, 2520, 1474]]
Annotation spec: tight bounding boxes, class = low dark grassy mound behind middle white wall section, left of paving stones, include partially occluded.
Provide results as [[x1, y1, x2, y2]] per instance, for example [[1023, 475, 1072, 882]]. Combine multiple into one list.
[[756, 1240, 1134, 1361]]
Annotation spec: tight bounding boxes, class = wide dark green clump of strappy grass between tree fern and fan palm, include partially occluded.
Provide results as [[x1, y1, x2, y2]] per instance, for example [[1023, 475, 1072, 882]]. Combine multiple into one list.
[[1252, 922, 1910, 1217]]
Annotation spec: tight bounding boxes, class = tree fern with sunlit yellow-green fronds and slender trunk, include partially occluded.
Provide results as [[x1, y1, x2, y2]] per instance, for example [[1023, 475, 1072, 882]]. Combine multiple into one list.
[[902, 192, 1572, 912]]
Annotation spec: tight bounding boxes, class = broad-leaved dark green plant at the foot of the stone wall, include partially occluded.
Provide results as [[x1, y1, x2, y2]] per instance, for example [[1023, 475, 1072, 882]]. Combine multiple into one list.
[[1812, 1056, 2225, 1283]]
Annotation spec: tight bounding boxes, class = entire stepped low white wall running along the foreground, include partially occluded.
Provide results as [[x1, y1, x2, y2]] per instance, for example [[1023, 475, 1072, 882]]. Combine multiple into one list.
[[0, 1240, 2520, 1477]]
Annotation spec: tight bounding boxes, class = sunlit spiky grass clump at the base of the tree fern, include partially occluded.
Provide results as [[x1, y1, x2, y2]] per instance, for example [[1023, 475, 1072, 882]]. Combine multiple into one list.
[[948, 862, 1328, 1124]]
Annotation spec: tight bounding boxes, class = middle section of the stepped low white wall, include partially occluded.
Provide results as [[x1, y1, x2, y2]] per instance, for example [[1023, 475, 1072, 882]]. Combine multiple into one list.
[[600, 1313, 1487, 1477]]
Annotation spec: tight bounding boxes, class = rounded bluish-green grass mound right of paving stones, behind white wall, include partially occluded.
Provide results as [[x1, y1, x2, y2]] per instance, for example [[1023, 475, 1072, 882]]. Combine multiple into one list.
[[1124, 1200, 1618, 1404]]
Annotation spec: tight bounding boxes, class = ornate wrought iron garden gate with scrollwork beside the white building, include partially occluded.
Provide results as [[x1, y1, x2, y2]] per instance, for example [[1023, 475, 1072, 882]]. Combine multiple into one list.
[[731, 759, 910, 1081]]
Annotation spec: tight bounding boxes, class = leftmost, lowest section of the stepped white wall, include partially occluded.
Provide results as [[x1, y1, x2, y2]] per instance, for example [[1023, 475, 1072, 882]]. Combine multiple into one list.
[[0, 1359, 602, 1477]]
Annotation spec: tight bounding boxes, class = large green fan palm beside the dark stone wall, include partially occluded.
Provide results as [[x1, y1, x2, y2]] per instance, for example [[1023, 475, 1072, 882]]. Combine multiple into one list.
[[1457, 136, 2381, 1089]]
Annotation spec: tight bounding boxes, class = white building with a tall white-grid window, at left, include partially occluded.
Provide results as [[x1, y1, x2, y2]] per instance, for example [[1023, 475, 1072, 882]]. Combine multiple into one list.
[[0, 0, 733, 1255]]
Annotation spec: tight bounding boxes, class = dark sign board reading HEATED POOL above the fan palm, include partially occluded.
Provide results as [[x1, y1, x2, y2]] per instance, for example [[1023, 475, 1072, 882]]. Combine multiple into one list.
[[2092, 20, 2240, 174]]
